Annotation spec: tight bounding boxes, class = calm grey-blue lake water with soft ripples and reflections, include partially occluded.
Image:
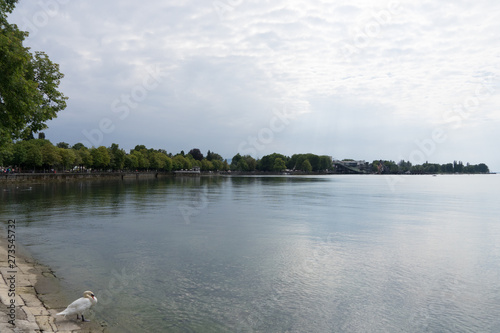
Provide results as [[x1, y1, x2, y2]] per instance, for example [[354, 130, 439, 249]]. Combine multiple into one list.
[[0, 175, 500, 332]]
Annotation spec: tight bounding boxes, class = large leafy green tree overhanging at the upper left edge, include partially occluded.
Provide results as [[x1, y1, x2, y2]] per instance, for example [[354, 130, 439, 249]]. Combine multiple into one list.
[[0, 0, 67, 145]]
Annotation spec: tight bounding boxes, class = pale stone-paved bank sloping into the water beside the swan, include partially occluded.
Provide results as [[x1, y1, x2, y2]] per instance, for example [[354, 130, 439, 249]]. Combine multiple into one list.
[[0, 226, 108, 333]]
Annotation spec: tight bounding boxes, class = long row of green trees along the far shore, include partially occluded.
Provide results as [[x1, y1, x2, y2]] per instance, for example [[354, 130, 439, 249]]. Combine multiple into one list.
[[0, 138, 490, 174]]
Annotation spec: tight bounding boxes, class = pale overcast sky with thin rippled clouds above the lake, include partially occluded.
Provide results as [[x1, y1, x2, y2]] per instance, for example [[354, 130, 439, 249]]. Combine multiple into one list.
[[6, 0, 500, 171]]
